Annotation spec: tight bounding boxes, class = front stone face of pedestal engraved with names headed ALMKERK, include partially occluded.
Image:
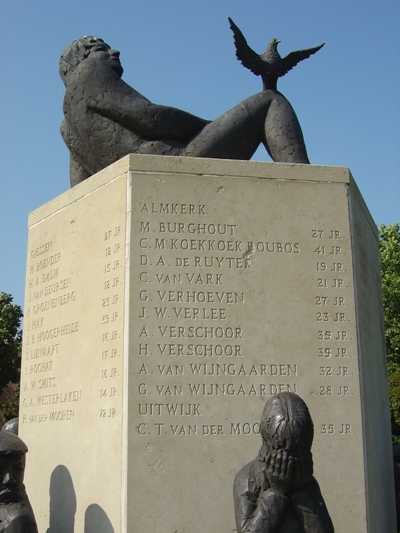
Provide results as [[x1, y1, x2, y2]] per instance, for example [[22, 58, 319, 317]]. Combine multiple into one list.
[[128, 170, 365, 532]]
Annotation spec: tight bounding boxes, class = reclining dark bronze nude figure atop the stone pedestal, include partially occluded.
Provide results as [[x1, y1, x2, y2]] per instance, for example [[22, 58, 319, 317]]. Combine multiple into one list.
[[60, 25, 318, 186]]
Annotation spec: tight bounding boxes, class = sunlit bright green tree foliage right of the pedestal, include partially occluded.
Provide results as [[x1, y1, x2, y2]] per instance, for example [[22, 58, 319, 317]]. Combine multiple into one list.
[[379, 222, 400, 374]]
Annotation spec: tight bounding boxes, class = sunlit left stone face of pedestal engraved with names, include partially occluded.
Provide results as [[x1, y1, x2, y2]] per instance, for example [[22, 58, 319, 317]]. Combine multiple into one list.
[[20, 177, 126, 531]]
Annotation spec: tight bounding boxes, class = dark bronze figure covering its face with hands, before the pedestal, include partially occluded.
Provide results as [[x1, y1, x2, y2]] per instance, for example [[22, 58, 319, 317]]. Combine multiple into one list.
[[233, 392, 334, 533]]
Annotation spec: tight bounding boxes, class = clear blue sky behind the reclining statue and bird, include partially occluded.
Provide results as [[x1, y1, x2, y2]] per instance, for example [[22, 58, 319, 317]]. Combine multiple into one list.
[[0, 0, 400, 305]]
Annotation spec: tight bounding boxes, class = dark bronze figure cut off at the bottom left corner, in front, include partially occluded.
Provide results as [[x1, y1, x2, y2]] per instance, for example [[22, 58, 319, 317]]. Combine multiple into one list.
[[0, 429, 38, 533]]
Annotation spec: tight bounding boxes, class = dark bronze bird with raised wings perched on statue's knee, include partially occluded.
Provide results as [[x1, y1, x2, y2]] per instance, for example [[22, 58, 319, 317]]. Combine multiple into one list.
[[228, 17, 325, 90]]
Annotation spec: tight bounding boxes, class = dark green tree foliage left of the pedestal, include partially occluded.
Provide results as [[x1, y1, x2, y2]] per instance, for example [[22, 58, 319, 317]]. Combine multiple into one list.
[[0, 292, 23, 392]]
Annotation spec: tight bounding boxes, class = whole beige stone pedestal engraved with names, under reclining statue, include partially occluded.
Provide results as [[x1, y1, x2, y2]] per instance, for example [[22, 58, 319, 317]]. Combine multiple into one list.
[[20, 152, 395, 533]]
